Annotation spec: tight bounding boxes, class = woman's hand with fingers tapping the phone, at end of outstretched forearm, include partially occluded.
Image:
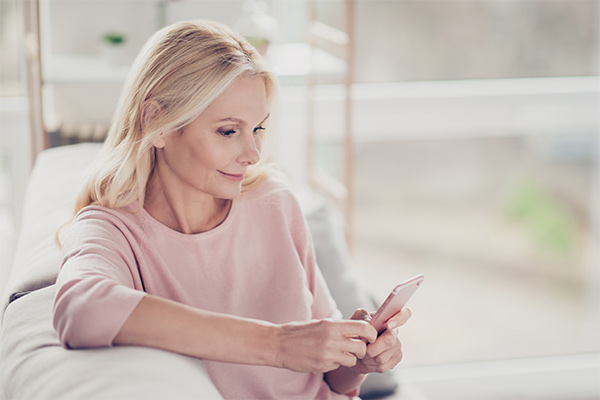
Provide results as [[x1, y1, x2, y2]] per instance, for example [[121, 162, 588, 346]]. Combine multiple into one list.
[[276, 319, 377, 373]]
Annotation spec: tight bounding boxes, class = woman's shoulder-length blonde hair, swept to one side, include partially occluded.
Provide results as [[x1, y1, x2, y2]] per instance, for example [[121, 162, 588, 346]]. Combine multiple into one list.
[[75, 20, 277, 214]]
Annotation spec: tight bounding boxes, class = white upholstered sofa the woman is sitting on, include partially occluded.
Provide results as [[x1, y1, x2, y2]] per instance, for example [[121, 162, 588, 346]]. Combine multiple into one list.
[[0, 143, 397, 399]]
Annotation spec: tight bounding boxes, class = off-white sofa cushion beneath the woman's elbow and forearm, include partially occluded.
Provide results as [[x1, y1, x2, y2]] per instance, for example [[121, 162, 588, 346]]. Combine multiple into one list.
[[0, 285, 222, 399]]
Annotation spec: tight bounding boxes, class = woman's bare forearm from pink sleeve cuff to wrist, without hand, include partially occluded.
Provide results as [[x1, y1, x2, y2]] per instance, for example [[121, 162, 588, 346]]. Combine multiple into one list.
[[113, 295, 277, 366]]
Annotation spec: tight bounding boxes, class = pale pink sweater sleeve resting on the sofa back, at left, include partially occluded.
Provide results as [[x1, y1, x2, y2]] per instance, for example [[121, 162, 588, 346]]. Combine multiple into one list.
[[53, 211, 145, 348]]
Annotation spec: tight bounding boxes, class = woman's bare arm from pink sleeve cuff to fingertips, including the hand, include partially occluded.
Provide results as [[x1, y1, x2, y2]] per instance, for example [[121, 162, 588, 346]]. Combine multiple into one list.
[[113, 295, 376, 373]]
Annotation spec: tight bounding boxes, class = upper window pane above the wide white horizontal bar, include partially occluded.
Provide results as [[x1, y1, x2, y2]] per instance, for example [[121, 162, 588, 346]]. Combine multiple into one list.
[[354, 0, 599, 82]]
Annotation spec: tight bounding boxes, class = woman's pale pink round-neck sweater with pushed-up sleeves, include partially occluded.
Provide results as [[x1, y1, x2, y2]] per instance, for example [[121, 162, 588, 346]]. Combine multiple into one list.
[[54, 180, 346, 399]]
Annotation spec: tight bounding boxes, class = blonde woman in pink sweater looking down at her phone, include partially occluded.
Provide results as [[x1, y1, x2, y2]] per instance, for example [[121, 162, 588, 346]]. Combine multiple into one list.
[[54, 21, 410, 399]]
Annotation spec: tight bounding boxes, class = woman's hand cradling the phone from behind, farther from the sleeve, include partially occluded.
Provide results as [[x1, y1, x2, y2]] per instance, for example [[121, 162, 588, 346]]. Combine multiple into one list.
[[351, 308, 411, 374]]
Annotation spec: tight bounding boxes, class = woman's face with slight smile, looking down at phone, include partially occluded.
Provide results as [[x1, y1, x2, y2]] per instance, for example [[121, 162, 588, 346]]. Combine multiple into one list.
[[154, 77, 269, 199]]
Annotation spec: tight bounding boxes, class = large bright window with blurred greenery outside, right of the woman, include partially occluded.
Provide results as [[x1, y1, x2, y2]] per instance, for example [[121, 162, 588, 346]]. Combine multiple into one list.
[[355, 1, 600, 365]]
